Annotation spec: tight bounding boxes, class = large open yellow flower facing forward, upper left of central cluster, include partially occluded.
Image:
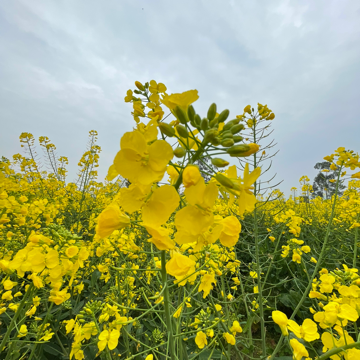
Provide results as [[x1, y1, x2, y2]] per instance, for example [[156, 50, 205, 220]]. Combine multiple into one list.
[[114, 130, 174, 185]]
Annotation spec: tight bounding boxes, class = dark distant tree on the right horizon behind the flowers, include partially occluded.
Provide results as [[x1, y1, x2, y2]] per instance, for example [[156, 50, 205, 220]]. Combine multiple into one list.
[[312, 161, 346, 199]]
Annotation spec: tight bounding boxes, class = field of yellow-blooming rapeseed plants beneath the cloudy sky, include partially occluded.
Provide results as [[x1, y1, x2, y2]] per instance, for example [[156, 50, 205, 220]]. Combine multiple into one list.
[[0, 80, 360, 360]]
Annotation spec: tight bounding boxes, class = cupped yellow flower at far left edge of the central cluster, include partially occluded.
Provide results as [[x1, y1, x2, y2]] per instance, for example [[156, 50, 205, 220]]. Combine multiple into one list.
[[96, 203, 130, 238]]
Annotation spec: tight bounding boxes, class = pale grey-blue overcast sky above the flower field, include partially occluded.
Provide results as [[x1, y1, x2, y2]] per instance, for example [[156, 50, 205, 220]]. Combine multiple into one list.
[[0, 0, 360, 193]]
